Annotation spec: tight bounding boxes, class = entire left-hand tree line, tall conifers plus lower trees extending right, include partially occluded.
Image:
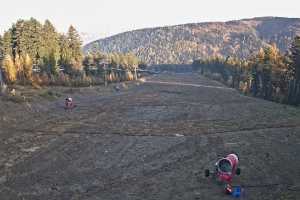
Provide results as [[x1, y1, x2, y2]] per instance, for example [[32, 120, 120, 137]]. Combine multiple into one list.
[[0, 18, 139, 85]]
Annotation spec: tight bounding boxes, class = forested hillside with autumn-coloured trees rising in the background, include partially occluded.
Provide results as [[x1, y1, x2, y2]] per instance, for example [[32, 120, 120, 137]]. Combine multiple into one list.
[[84, 17, 300, 64]]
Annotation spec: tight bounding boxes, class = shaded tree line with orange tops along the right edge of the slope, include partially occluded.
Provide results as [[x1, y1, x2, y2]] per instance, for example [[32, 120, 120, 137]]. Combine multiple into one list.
[[193, 36, 300, 105]]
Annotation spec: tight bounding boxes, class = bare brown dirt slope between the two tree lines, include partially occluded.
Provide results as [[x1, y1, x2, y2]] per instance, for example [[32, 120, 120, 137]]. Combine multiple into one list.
[[0, 73, 300, 200]]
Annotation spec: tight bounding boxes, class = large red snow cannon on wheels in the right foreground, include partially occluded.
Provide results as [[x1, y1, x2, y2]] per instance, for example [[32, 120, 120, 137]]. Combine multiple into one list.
[[205, 154, 241, 184]]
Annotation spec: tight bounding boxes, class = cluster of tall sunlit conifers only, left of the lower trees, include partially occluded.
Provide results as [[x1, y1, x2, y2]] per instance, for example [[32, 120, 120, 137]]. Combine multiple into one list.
[[0, 18, 83, 83]]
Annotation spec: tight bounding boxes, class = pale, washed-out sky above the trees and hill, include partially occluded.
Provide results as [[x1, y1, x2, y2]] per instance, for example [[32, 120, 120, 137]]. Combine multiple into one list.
[[0, 0, 300, 42]]
